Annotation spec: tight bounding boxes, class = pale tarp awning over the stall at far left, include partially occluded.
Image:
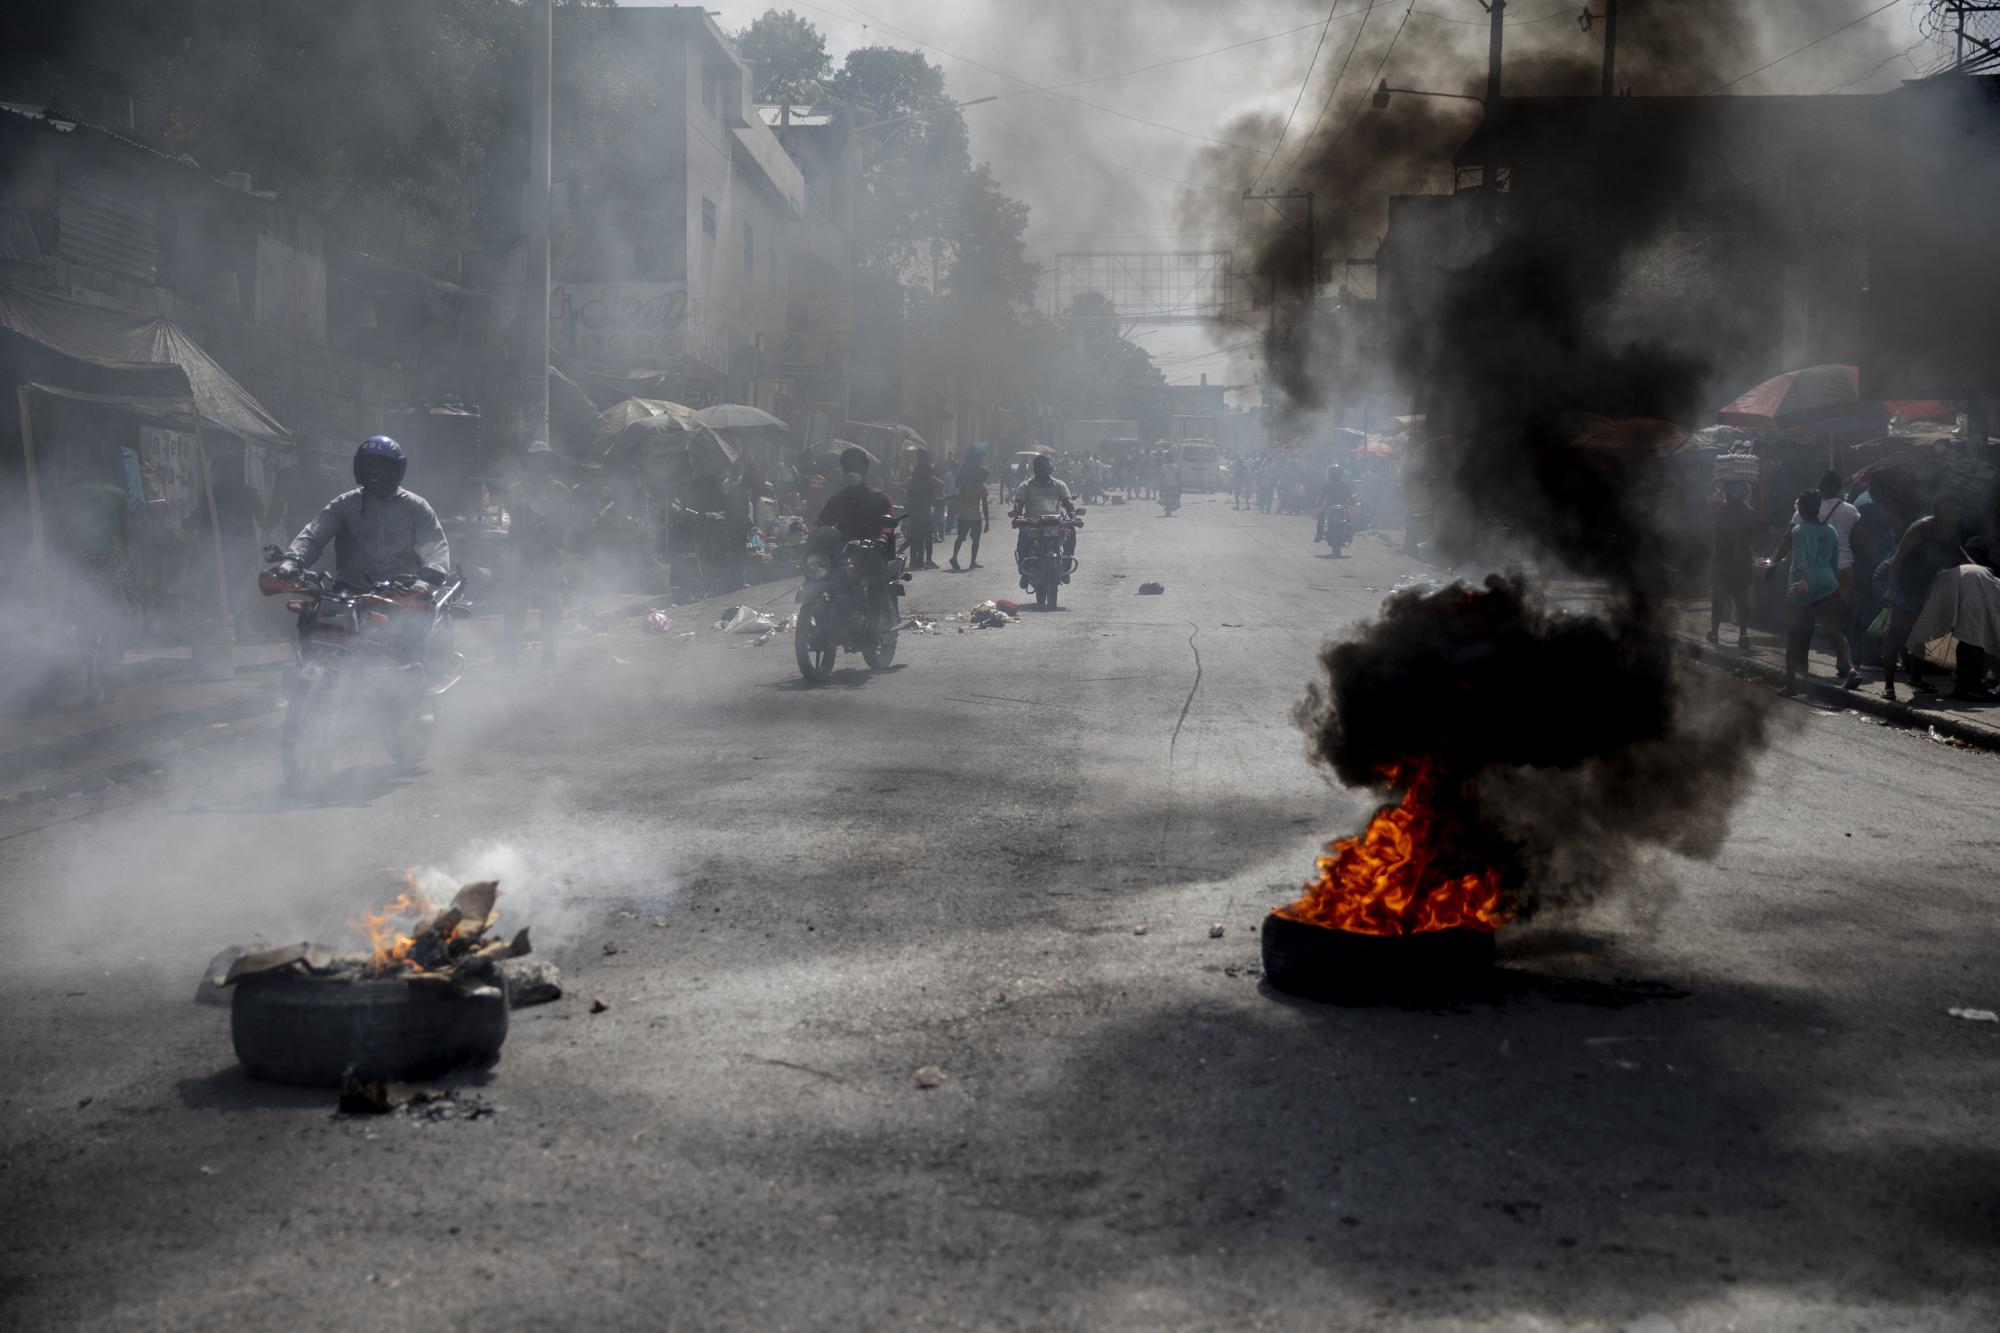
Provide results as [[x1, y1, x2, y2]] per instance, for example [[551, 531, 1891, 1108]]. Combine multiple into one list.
[[0, 284, 292, 444]]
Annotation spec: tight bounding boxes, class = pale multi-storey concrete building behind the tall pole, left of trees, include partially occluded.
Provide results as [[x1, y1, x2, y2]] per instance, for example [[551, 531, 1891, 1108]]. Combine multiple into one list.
[[550, 6, 806, 414]]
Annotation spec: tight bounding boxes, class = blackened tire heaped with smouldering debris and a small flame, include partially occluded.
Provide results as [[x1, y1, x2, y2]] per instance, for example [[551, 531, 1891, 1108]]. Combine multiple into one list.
[[230, 975, 506, 1087]]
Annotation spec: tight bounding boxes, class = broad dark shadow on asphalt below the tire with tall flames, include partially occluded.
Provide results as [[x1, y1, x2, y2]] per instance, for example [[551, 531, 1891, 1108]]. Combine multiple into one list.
[[1000, 956, 2000, 1327]]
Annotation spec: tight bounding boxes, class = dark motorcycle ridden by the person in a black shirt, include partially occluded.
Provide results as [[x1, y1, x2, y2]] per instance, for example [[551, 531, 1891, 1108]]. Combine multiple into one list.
[[792, 518, 910, 685]]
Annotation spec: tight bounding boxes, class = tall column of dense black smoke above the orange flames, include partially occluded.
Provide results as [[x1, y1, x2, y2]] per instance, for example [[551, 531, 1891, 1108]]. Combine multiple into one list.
[[1266, 4, 1832, 915]]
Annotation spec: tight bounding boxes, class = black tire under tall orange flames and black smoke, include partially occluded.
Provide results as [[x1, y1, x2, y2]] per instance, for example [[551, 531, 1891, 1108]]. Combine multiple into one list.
[[1264, 913, 1494, 1003]]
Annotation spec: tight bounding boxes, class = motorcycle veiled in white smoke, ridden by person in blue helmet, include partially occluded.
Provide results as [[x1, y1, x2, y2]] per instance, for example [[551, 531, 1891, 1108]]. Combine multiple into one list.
[[258, 546, 472, 795]]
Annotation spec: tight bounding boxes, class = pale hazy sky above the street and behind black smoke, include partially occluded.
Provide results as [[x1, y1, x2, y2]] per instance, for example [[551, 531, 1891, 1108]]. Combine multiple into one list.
[[652, 0, 1936, 384]]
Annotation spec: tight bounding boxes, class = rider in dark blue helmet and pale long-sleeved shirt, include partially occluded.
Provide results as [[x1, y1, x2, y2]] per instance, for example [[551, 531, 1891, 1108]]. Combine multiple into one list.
[[278, 434, 452, 588]]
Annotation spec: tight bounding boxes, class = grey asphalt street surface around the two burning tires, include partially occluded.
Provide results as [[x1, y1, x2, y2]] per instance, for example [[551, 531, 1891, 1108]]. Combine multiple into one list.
[[0, 496, 2000, 1333]]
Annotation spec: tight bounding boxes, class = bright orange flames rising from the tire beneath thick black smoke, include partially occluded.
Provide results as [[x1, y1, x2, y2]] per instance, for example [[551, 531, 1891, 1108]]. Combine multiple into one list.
[[1278, 763, 1512, 935]]
